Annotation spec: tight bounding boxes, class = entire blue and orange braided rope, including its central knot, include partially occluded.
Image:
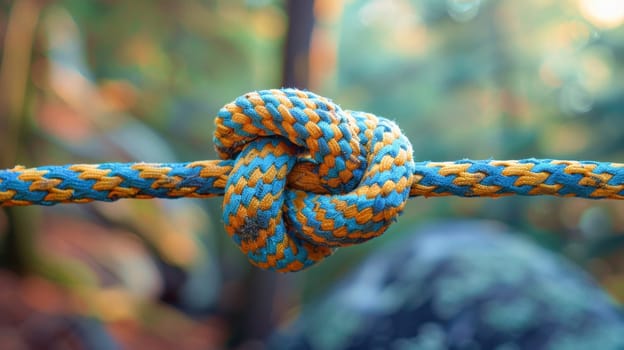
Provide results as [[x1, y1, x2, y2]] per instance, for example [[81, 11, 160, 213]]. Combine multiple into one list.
[[0, 89, 624, 271]]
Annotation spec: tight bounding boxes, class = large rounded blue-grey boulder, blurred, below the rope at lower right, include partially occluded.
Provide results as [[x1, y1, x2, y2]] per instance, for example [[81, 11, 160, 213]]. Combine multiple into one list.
[[270, 221, 624, 350]]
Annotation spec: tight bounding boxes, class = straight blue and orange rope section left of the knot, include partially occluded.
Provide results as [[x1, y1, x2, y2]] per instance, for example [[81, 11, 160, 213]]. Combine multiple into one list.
[[0, 161, 233, 206]]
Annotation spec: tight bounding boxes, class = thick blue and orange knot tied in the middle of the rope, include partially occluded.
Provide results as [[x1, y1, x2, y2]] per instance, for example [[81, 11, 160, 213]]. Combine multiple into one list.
[[214, 89, 415, 271]]
